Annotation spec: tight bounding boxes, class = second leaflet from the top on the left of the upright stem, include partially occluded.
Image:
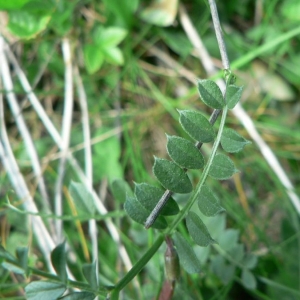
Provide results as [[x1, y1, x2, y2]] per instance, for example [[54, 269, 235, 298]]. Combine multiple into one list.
[[178, 110, 215, 143]]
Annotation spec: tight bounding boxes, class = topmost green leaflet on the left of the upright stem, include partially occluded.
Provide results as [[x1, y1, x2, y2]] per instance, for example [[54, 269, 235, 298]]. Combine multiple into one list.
[[198, 79, 225, 109]]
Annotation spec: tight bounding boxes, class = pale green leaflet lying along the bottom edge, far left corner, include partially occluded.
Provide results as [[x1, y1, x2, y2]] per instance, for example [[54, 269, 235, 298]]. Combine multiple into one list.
[[25, 281, 66, 300]]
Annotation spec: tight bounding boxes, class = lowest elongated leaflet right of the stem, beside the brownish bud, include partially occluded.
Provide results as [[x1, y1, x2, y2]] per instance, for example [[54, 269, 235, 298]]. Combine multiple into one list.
[[173, 232, 201, 274]]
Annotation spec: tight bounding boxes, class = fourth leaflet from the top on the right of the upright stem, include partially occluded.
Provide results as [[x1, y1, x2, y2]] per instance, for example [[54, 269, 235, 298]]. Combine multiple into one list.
[[197, 185, 225, 217]]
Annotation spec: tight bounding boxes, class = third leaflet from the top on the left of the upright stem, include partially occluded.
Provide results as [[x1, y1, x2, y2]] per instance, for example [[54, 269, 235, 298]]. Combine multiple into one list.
[[167, 135, 204, 169]]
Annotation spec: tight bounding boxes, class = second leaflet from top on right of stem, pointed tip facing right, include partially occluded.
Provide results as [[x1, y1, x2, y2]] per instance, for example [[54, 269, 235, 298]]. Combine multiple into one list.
[[221, 128, 251, 153]]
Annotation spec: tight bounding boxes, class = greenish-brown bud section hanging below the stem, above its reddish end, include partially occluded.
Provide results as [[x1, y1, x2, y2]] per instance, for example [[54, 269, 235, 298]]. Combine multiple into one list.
[[165, 237, 180, 282]]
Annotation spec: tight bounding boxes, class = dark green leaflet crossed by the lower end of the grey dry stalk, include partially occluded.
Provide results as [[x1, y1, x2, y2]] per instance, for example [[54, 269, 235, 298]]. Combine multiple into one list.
[[134, 183, 179, 216]]
